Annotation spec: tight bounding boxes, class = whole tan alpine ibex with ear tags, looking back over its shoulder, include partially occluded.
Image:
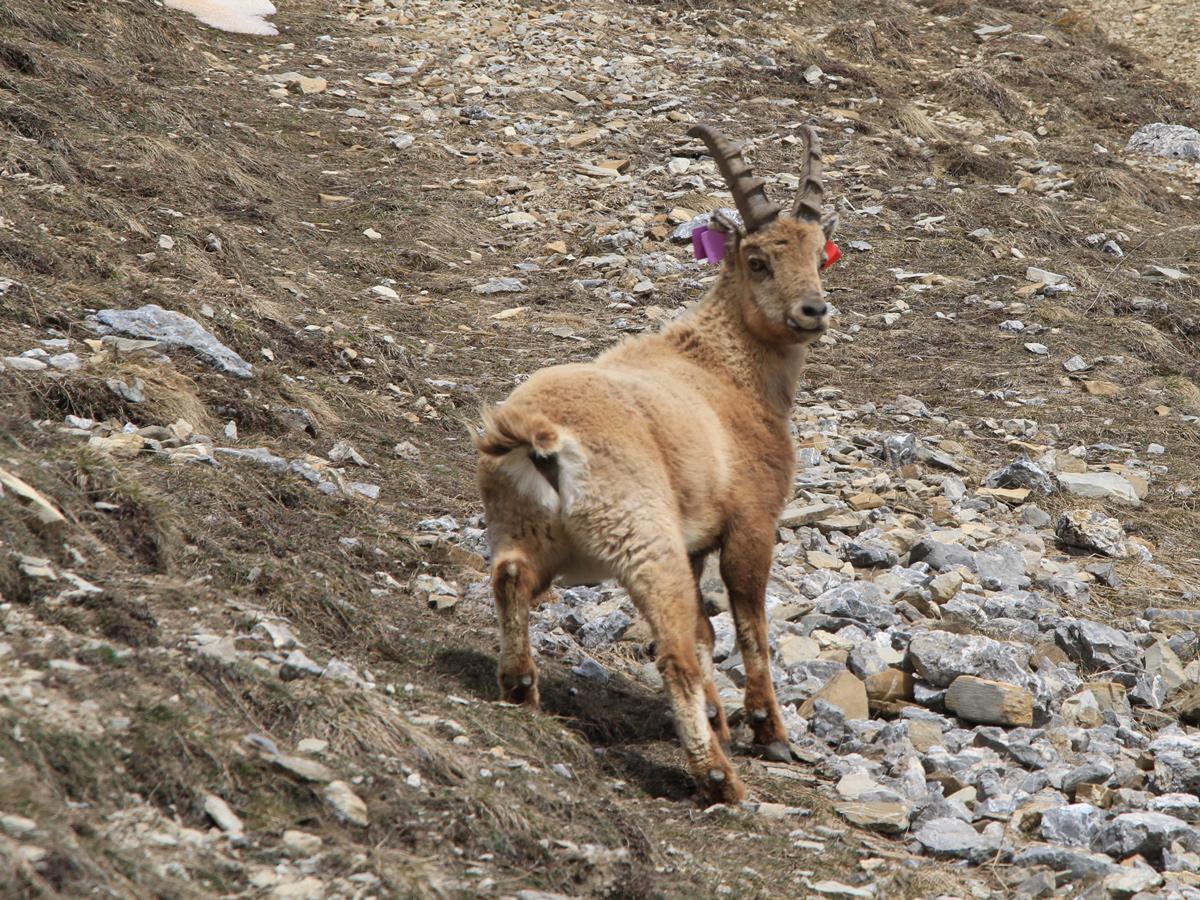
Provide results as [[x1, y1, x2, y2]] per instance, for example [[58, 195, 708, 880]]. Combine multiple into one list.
[[475, 126, 836, 802]]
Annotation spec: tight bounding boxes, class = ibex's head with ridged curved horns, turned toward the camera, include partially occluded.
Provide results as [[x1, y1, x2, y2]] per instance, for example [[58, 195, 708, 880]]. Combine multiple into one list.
[[688, 125, 838, 344]]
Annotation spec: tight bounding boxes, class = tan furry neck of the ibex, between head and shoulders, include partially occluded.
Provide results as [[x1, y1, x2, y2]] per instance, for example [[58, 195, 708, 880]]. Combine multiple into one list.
[[672, 268, 808, 418]]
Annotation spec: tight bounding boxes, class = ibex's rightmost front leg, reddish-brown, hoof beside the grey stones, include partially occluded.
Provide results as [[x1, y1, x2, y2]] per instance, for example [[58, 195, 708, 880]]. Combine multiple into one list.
[[721, 523, 792, 762]]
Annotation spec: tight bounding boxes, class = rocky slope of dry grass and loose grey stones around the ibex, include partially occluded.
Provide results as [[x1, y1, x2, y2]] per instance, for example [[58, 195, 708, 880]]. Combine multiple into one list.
[[0, 0, 1200, 899]]
